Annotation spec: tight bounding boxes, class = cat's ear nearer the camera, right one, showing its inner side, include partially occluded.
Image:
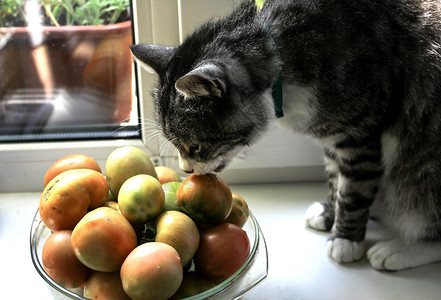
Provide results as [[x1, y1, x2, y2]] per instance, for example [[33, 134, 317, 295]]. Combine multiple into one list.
[[175, 65, 226, 98]]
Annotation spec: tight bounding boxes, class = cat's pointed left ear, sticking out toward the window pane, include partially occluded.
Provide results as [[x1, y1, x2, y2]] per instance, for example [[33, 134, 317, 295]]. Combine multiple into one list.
[[130, 44, 176, 75]]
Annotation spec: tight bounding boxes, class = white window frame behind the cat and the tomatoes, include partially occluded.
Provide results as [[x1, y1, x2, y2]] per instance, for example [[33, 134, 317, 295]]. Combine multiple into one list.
[[0, 0, 324, 193]]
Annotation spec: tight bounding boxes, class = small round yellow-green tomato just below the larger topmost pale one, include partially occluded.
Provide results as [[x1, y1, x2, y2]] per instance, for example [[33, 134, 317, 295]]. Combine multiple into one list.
[[118, 174, 165, 224]]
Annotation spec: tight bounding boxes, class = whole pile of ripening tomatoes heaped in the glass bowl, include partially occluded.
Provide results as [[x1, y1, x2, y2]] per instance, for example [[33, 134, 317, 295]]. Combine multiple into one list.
[[39, 146, 250, 299]]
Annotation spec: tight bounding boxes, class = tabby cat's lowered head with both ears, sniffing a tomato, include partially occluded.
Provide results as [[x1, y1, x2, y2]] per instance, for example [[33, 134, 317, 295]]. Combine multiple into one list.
[[131, 39, 273, 174]]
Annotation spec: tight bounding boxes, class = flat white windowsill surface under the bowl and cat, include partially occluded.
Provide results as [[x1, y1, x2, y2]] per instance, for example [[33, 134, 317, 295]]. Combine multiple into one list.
[[0, 183, 441, 300]]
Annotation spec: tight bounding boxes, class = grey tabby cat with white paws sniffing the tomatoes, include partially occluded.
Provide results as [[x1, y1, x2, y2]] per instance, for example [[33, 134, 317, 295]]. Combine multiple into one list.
[[131, 0, 441, 270]]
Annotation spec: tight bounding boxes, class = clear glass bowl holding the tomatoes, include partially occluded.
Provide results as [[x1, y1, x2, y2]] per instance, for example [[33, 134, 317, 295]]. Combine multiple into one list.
[[30, 210, 268, 300]]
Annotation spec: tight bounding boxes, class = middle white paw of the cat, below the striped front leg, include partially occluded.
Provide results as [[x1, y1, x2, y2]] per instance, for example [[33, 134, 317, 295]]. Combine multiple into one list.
[[327, 238, 364, 263]]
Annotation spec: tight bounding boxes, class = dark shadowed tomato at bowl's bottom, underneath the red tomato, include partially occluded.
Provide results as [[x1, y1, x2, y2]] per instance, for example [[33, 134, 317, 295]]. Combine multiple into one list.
[[170, 272, 216, 300]]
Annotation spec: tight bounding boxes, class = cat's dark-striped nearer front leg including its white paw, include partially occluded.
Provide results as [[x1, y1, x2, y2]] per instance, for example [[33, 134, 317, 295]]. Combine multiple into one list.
[[327, 147, 383, 263]]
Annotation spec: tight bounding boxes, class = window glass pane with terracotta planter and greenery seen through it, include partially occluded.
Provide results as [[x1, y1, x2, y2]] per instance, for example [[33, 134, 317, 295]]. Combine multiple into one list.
[[0, 0, 139, 142]]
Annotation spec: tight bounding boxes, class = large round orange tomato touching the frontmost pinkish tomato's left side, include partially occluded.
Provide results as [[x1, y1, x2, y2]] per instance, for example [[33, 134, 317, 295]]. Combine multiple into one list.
[[72, 207, 137, 272]]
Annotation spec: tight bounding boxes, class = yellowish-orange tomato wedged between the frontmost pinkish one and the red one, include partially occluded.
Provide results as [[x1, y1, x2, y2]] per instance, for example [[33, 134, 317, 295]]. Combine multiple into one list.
[[155, 210, 199, 266]]
